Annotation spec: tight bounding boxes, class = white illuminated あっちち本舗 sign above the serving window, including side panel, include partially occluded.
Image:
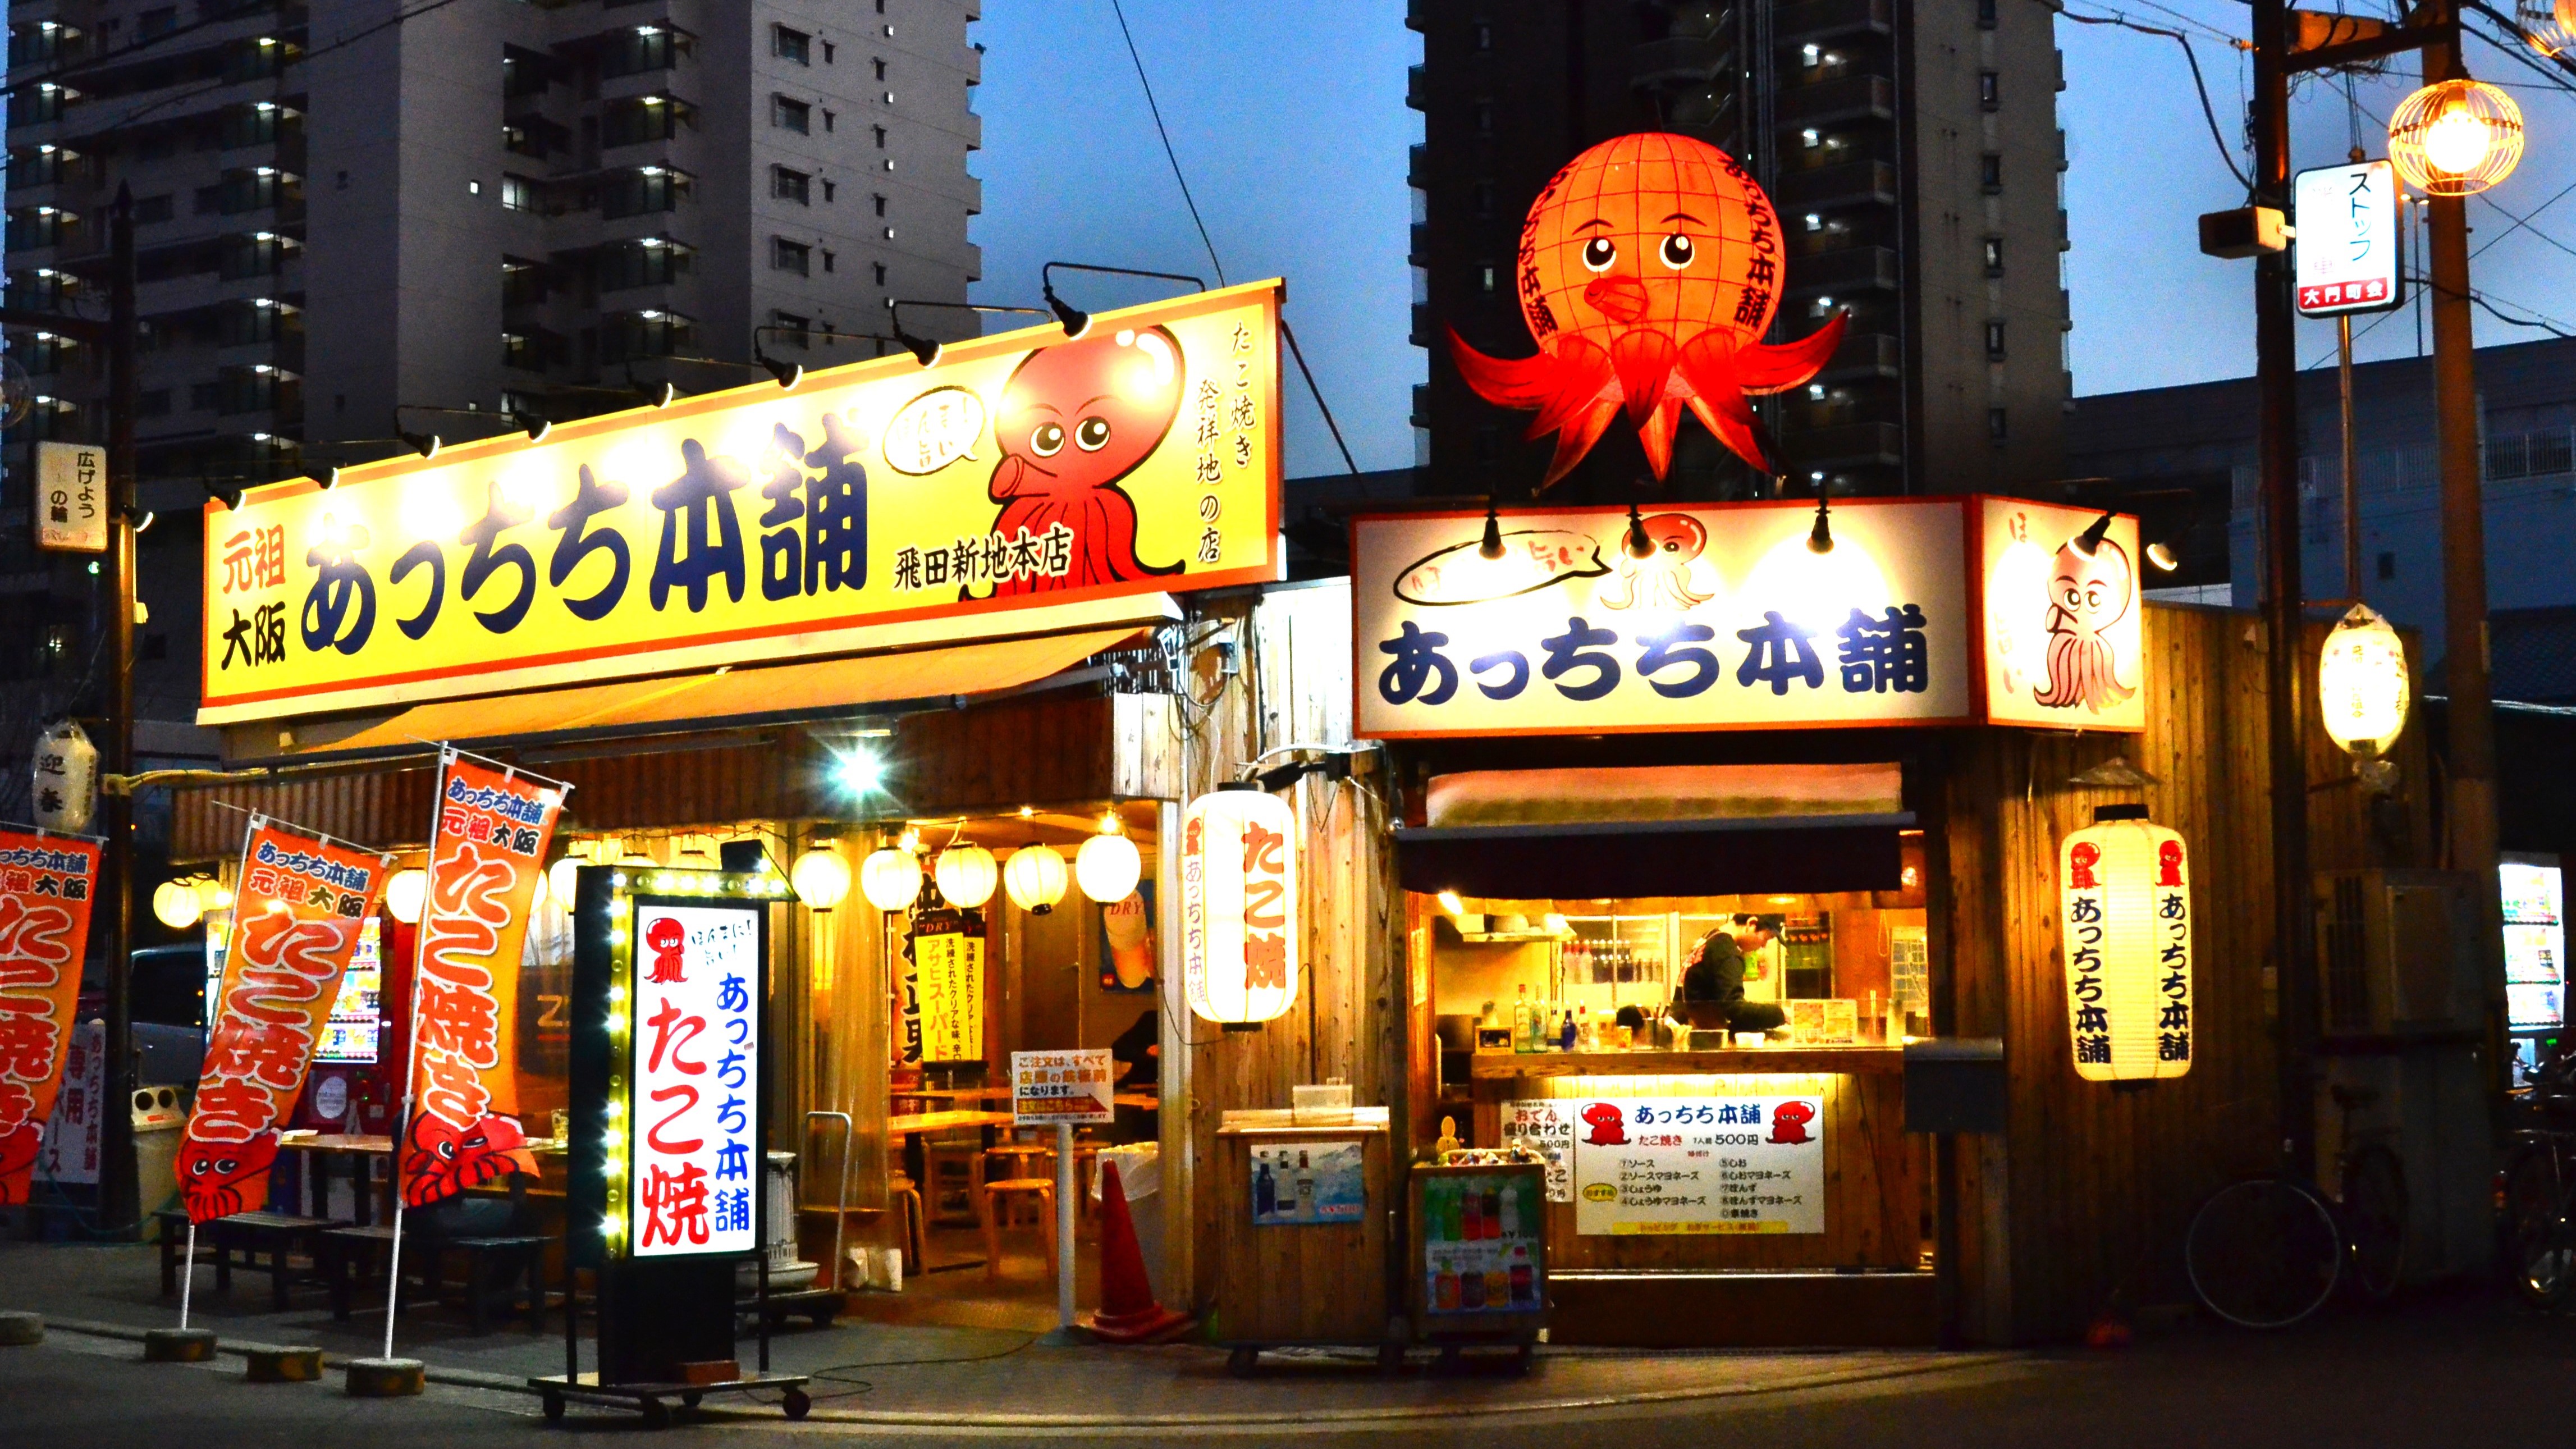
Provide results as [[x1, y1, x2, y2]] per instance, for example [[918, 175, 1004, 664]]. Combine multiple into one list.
[[1352, 497, 2143, 737]]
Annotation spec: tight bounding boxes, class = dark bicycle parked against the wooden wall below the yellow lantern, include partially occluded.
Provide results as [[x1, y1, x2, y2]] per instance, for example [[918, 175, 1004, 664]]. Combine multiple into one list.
[[2182, 1088, 2409, 1328]]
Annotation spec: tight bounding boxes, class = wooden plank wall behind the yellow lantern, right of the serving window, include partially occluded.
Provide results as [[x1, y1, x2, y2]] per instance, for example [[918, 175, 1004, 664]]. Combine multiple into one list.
[[1924, 606, 2432, 1343]]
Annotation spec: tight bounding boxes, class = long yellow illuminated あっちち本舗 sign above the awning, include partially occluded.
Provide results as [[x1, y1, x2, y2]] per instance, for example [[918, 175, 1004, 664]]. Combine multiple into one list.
[[198, 281, 1283, 725]]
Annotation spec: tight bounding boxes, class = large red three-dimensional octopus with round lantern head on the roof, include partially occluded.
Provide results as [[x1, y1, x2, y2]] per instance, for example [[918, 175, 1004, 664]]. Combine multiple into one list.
[[1451, 131, 1847, 487]]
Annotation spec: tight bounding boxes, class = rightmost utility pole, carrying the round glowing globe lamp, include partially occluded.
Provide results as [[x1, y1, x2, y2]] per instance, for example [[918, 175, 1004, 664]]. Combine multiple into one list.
[[2424, 0, 2511, 1088]]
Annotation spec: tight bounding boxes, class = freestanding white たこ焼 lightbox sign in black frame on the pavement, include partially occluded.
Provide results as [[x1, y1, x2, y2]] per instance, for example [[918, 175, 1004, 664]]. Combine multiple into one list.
[[569, 866, 788, 1263]]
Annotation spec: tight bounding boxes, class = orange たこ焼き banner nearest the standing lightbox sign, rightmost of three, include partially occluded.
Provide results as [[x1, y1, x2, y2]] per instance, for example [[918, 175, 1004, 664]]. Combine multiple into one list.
[[399, 750, 567, 1206]]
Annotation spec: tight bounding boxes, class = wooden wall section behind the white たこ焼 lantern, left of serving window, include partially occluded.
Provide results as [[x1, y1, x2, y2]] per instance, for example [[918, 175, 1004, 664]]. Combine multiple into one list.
[[1162, 580, 1409, 1320]]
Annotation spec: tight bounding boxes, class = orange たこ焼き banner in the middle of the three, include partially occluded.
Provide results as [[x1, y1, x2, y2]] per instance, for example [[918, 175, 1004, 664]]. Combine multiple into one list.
[[178, 815, 394, 1222]]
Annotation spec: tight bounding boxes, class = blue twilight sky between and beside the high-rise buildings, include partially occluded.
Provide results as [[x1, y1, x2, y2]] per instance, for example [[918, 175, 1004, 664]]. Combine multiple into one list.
[[971, 0, 2576, 477]]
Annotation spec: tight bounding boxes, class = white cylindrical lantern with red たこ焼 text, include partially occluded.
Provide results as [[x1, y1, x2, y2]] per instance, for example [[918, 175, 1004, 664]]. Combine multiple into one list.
[[1180, 784, 1298, 1026]]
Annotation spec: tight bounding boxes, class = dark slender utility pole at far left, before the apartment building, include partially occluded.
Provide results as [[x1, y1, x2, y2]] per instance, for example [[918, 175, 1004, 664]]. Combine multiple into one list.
[[98, 183, 141, 1237]]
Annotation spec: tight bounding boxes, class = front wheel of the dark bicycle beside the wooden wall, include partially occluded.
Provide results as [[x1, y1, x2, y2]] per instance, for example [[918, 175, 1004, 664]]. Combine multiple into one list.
[[2182, 1178, 2344, 1328]]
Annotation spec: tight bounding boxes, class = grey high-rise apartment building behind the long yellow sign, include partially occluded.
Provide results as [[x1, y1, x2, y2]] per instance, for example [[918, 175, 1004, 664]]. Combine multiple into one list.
[[8, 0, 981, 482]]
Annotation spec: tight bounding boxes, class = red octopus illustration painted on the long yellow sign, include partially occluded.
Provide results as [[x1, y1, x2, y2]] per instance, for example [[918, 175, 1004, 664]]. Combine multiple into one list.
[[987, 327, 1185, 596]]
